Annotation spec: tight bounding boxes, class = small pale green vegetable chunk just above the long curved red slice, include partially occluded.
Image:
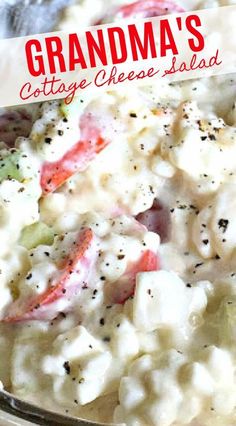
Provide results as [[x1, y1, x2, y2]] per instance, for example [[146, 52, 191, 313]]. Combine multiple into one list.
[[19, 222, 54, 250]]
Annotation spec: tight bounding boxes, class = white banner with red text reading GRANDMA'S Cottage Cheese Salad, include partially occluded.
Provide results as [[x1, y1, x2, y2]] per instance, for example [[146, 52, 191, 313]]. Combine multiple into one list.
[[0, 6, 236, 106]]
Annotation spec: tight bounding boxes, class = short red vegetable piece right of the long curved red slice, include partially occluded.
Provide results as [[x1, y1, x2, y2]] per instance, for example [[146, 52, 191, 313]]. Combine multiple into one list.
[[109, 250, 160, 304]]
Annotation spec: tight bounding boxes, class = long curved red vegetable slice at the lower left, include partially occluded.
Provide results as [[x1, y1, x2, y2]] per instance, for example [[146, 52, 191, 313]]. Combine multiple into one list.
[[3, 228, 98, 323]]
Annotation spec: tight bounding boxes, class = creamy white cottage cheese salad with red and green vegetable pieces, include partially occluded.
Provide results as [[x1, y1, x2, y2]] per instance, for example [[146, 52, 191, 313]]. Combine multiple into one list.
[[0, 0, 236, 426]]
